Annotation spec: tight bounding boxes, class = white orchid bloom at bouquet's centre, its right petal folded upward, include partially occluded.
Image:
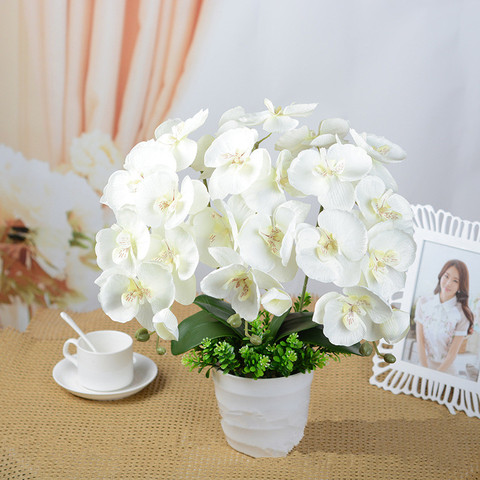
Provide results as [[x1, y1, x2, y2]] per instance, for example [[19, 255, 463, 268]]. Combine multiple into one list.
[[238, 200, 310, 282]]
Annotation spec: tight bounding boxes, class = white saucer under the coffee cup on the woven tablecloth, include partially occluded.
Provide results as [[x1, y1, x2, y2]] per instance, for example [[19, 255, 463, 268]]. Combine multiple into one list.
[[52, 352, 158, 400]]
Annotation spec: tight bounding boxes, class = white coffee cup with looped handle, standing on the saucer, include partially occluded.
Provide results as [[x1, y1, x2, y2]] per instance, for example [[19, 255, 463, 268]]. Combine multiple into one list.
[[63, 330, 134, 392]]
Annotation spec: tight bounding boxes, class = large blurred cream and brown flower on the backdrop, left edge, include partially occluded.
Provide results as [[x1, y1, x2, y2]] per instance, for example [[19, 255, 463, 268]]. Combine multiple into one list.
[[0, 138, 116, 328]]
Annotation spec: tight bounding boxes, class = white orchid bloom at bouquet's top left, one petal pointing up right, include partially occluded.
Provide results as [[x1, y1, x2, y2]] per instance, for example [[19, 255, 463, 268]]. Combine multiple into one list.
[[155, 110, 208, 171]]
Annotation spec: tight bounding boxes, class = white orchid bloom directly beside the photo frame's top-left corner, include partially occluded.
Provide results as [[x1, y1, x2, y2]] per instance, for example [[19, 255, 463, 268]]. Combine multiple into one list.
[[355, 175, 413, 233]]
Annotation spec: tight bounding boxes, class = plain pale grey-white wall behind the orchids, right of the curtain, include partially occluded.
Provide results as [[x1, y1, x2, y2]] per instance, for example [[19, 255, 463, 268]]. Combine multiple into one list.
[[170, 0, 480, 220]]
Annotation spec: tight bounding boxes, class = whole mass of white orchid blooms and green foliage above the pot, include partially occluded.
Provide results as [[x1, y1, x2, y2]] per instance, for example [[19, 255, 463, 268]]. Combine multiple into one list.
[[96, 100, 416, 378]]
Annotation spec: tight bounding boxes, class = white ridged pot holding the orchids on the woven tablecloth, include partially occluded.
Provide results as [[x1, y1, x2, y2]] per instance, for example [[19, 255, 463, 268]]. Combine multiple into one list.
[[212, 370, 313, 458]]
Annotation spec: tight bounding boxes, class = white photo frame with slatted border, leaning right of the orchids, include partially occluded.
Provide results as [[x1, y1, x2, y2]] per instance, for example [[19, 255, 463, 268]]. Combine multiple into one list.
[[370, 205, 480, 418]]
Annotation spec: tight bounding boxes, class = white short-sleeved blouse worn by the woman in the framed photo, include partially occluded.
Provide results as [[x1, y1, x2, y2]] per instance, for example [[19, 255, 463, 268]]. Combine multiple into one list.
[[415, 294, 468, 362]]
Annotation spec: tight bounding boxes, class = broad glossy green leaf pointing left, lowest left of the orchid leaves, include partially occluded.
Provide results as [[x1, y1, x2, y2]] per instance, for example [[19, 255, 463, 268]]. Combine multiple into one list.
[[170, 310, 236, 355]]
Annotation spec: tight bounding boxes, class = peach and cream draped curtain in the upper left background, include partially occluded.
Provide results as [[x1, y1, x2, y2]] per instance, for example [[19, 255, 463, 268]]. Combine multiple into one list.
[[9, 0, 203, 165]]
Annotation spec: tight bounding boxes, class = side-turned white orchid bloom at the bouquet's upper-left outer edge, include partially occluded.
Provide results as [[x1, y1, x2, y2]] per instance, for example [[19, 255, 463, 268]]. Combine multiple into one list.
[[100, 140, 176, 212]]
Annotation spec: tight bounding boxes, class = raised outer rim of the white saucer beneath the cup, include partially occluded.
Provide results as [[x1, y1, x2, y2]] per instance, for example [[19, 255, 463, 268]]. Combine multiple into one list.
[[52, 352, 158, 400]]
